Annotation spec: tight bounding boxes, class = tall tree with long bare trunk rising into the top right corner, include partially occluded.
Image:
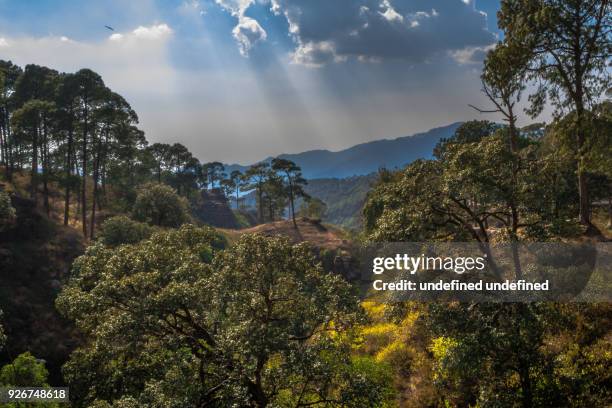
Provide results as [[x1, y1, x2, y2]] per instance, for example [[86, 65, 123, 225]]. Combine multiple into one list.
[[498, 0, 612, 227]]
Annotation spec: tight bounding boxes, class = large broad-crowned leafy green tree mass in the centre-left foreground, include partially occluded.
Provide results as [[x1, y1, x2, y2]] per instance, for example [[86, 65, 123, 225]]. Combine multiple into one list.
[[57, 226, 388, 407]]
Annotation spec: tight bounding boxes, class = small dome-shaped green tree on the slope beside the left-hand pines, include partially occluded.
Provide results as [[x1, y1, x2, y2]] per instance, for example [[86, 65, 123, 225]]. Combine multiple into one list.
[[132, 183, 190, 228]]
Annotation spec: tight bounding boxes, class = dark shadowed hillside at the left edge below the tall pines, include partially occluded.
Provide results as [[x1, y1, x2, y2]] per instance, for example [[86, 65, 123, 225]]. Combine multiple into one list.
[[0, 195, 84, 384]]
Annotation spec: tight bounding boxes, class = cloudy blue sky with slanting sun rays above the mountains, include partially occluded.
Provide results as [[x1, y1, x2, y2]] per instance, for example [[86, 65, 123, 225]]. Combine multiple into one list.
[[0, 0, 536, 164]]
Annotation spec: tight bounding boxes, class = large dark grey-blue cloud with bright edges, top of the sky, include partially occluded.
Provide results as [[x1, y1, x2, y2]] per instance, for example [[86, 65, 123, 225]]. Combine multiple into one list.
[[271, 0, 495, 65]]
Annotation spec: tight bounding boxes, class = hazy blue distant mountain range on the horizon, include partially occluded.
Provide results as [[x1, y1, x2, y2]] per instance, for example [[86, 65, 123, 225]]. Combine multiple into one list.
[[225, 122, 461, 179]]
